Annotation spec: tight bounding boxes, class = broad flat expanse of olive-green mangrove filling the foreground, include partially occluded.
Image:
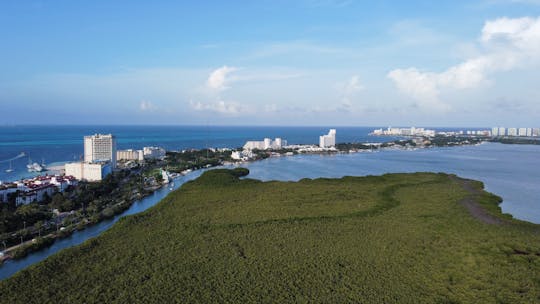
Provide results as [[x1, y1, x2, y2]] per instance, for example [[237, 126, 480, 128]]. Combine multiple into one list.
[[0, 169, 540, 303]]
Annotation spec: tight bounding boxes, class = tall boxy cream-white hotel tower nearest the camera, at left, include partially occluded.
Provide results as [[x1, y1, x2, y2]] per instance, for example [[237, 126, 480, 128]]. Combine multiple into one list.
[[84, 134, 116, 168]]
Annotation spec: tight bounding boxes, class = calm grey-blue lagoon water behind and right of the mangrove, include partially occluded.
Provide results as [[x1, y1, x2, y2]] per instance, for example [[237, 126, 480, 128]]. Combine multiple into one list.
[[247, 143, 540, 223]]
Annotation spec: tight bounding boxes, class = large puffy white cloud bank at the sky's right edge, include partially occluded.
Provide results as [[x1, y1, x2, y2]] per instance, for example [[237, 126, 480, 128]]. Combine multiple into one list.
[[387, 17, 540, 111]]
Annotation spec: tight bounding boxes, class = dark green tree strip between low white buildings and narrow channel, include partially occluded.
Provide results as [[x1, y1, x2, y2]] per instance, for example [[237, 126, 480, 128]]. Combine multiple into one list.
[[0, 170, 150, 249]]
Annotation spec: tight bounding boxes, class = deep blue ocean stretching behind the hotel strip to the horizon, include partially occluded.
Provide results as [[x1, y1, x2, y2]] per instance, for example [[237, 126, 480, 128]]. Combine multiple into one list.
[[0, 126, 480, 181]]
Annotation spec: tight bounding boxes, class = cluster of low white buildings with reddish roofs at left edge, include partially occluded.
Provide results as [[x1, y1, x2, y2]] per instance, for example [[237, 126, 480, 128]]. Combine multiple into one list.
[[0, 175, 77, 205]]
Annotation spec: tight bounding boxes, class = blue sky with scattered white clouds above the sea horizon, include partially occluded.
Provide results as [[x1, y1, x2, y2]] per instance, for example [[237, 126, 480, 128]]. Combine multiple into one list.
[[0, 0, 540, 127]]
